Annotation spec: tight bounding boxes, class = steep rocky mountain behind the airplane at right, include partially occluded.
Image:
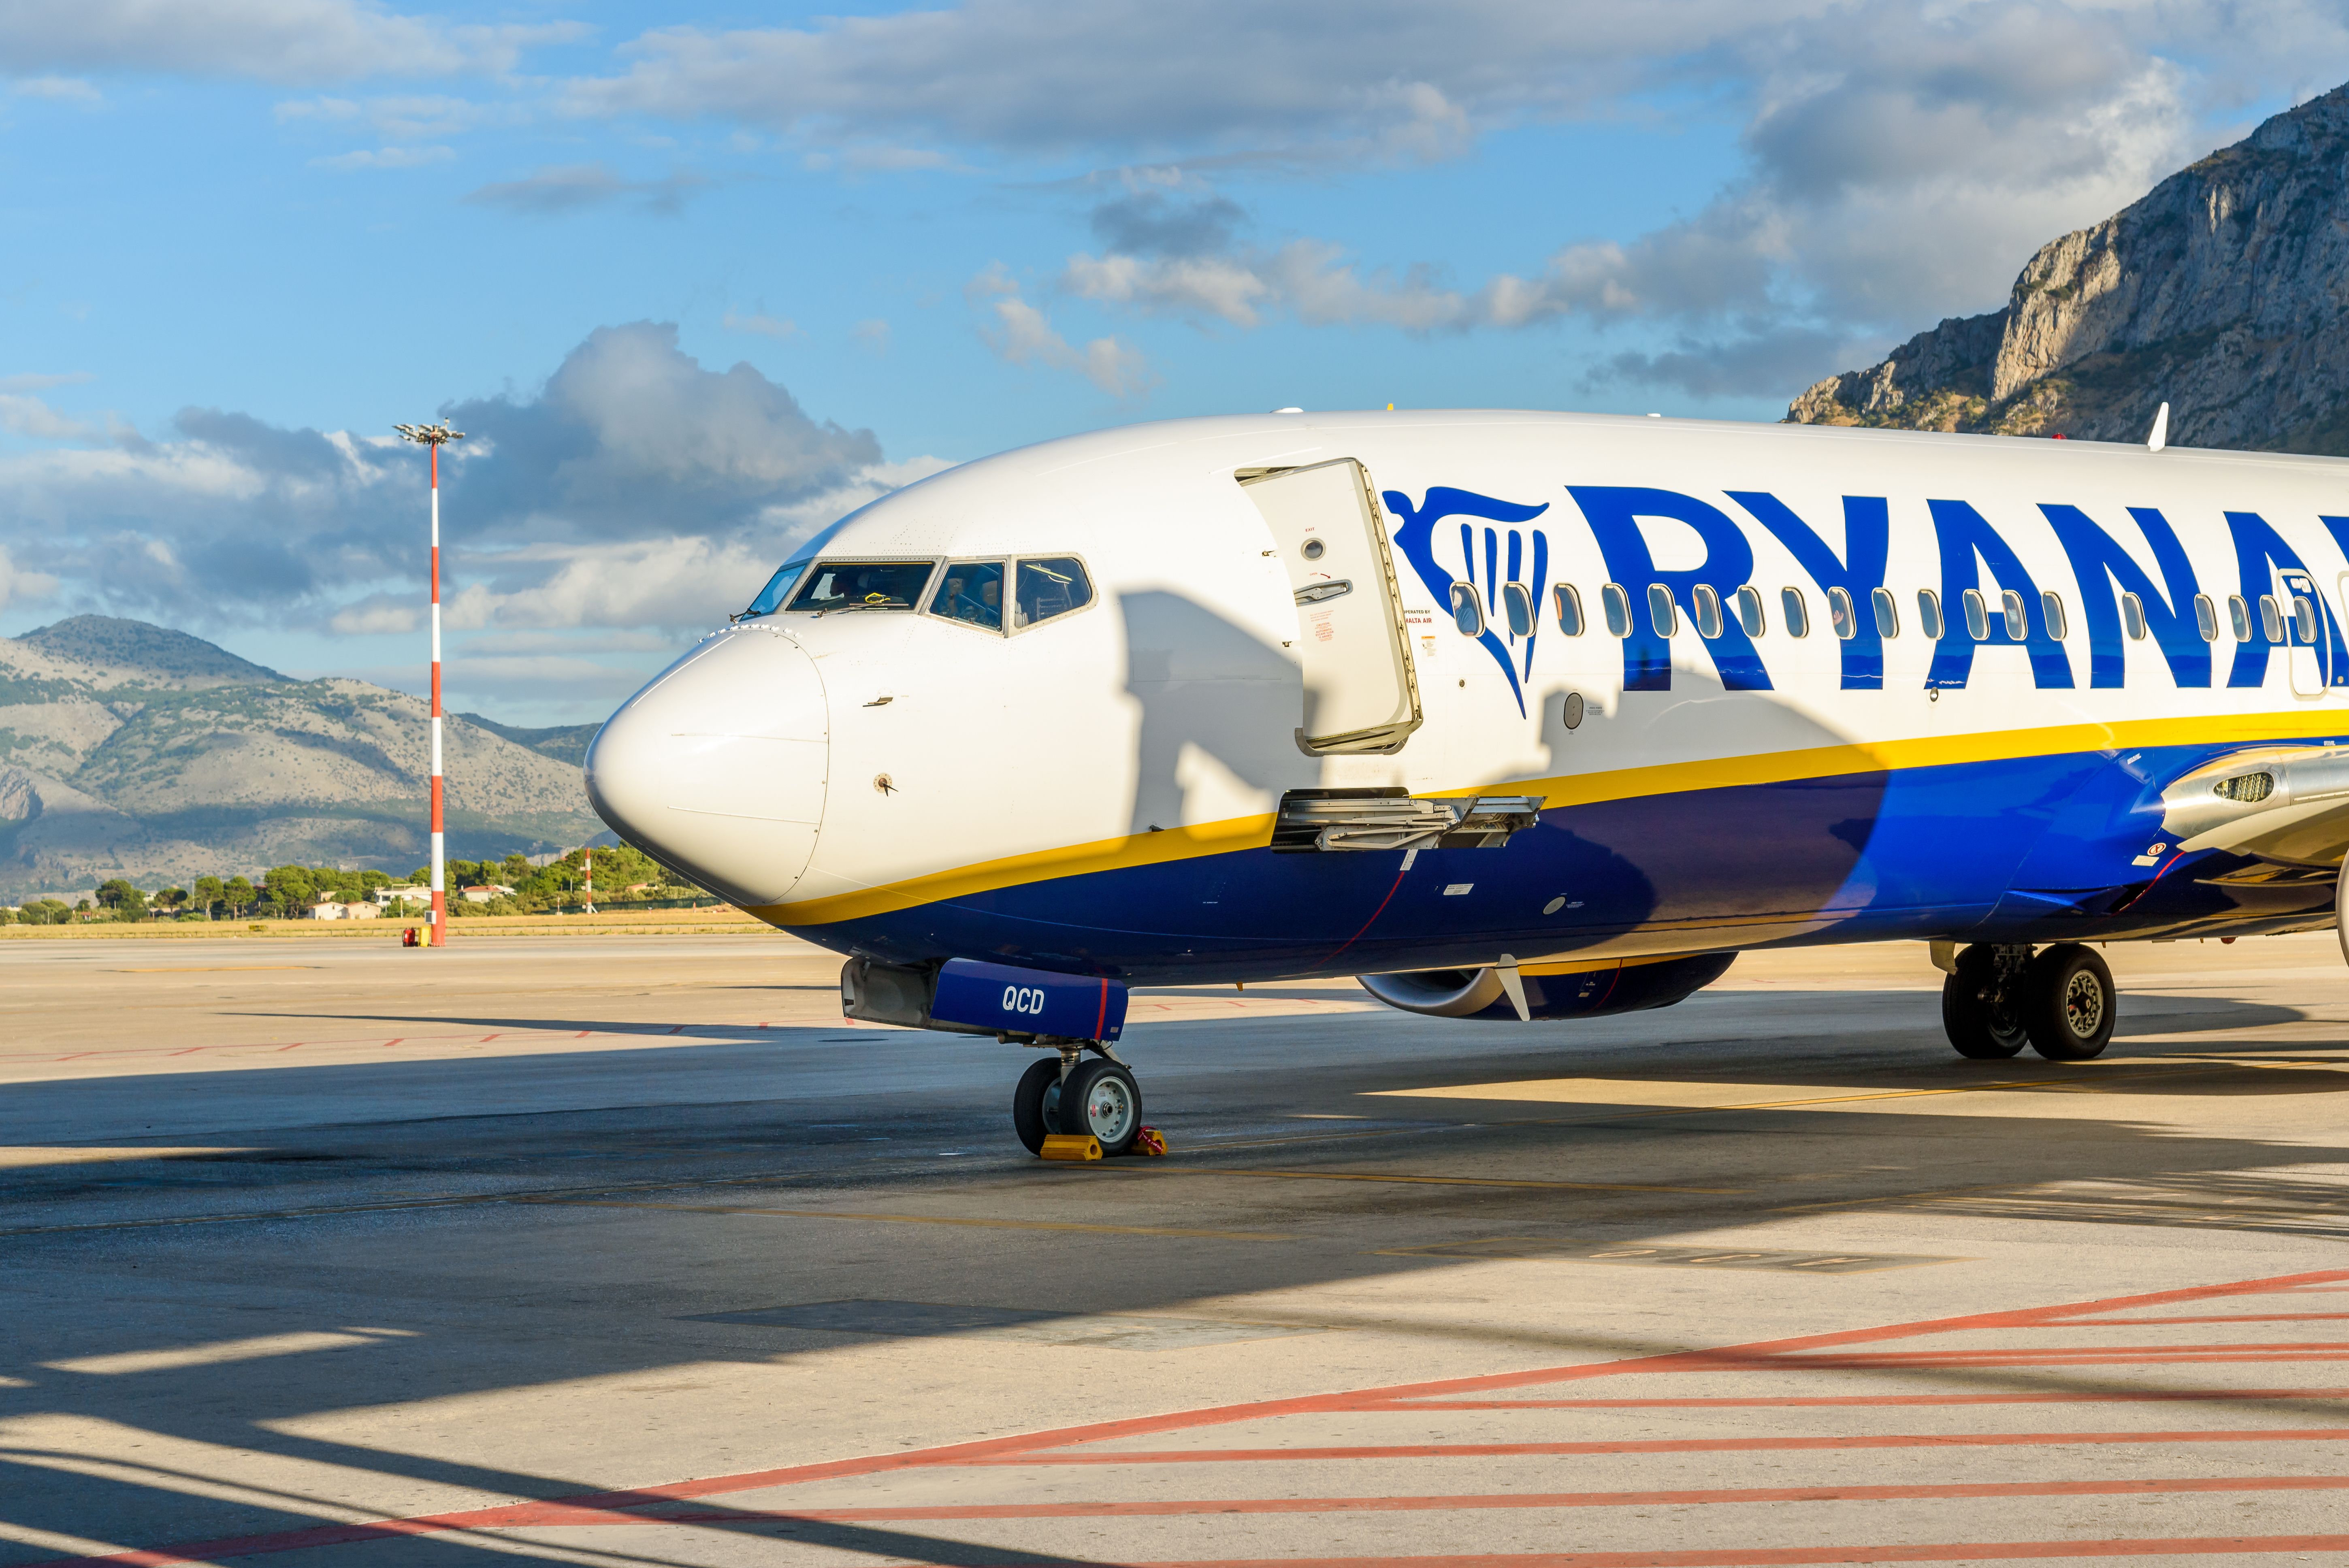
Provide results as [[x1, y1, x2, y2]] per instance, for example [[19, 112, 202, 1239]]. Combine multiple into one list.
[[1788, 87, 2349, 456]]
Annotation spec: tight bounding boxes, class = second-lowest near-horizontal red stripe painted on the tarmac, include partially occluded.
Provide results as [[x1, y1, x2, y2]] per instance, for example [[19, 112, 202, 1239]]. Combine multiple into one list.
[[653, 1476, 2349, 1523]]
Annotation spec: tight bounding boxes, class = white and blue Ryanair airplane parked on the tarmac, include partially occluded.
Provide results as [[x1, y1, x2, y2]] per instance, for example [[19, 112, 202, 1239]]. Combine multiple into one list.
[[585, 406, 2349, 1155]]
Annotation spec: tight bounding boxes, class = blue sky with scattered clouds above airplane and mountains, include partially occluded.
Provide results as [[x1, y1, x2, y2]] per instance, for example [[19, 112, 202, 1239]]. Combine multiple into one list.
[[0, 0, 2349, 723]]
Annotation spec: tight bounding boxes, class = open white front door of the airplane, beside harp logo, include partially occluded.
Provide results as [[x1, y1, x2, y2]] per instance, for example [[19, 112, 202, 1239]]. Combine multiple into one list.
[[1238, 458, 1421, 756]]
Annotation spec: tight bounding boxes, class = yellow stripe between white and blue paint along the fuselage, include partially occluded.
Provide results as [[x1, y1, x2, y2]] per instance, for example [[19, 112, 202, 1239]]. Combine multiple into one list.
[[747, 704, 2349, 927]]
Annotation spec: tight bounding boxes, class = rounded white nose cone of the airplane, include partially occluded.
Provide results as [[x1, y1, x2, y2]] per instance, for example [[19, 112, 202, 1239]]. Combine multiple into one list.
[[587, 627, 829, 908]]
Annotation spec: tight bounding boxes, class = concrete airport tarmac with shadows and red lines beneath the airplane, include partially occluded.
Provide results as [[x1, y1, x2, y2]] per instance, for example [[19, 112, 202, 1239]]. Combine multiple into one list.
[[0, 937, 2349, 1568]]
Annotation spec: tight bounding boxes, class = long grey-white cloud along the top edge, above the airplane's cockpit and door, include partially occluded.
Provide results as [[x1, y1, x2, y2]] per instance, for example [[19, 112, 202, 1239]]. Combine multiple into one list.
[[569, 0, 1757, 160]]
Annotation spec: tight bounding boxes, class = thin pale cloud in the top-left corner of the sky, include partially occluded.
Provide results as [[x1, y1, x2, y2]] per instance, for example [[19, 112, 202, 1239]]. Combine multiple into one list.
[[0, 0, 585, 82]]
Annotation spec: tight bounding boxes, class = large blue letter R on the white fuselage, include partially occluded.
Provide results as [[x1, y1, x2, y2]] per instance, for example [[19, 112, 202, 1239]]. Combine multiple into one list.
[[1567, 484, 1771, 692]]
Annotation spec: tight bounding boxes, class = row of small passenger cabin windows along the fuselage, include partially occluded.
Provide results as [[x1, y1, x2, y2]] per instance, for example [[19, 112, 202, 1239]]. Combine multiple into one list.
[[1452, 582, 2316, 643]]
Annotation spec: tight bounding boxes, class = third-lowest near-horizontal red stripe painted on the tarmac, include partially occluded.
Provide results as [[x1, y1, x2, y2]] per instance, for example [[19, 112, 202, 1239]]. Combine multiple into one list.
[[954, 1427, 2349, 1467]]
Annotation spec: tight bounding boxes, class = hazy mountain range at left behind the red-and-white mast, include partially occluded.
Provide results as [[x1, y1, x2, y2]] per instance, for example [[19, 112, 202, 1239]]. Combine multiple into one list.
[[0, 615, 601, 901]]
